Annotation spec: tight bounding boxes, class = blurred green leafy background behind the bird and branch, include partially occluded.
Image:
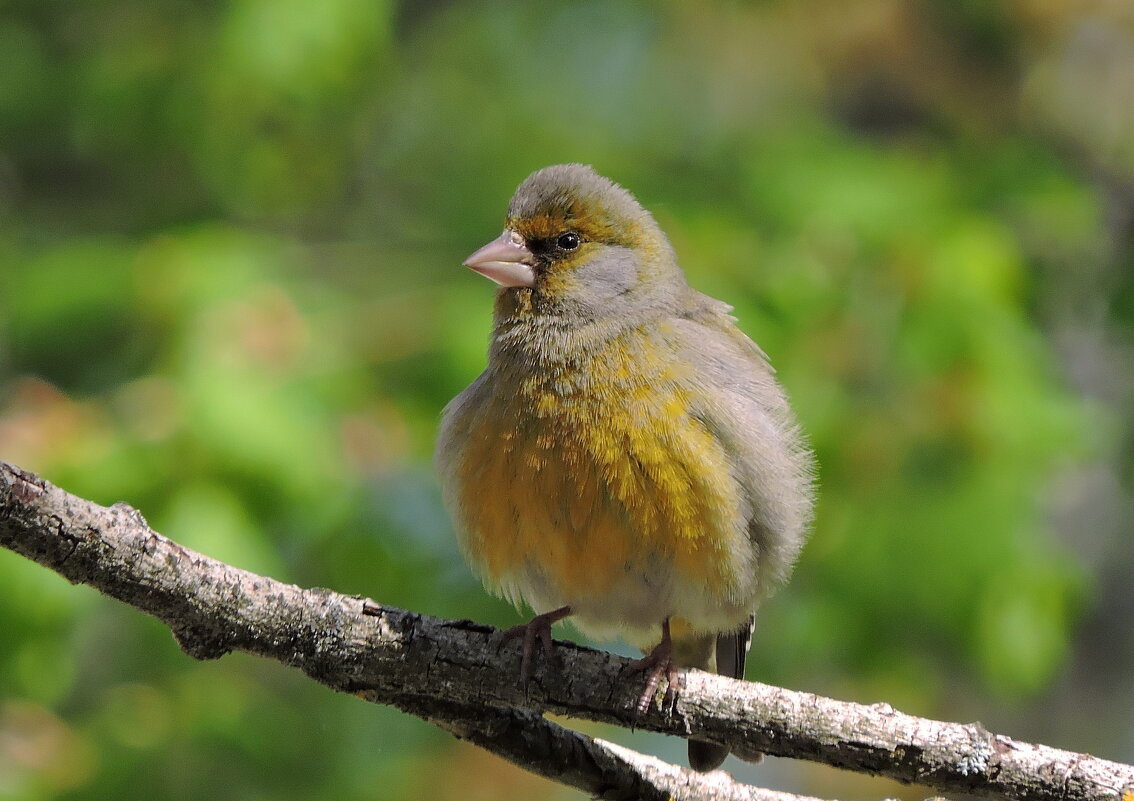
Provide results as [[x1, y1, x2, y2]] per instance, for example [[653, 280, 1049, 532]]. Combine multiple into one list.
[[0, 0, 1134, 801]]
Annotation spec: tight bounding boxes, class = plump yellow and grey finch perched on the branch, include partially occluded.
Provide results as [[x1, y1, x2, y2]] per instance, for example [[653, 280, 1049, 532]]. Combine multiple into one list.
[[435, 163, 813, 770]]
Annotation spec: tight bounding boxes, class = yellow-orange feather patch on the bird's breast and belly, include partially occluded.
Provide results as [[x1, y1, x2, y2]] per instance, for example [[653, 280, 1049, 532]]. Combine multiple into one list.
[[458, 331, 746, 597]]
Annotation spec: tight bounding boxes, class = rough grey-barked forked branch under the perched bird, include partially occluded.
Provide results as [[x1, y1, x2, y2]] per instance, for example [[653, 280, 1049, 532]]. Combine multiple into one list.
[[0, 462, 1134, 801]]
